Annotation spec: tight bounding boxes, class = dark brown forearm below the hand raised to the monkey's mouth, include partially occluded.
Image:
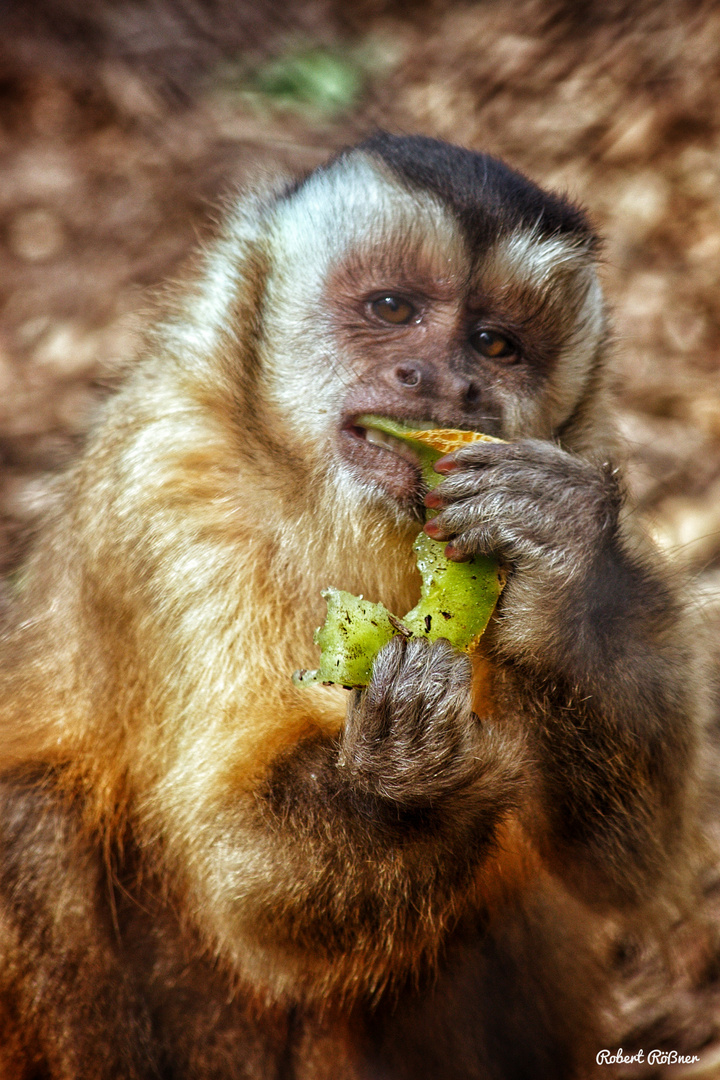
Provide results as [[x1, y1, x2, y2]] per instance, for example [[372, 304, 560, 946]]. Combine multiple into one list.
[[502, 539, 698, 895]]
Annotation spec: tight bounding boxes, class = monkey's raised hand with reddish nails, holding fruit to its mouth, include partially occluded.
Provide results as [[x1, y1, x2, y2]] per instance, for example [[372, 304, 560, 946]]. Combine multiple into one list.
[[425, 440, 622, 657]]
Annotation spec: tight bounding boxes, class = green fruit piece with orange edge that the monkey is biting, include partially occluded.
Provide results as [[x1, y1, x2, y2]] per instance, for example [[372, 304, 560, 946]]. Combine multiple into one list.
[[293, 416, 505, 688]]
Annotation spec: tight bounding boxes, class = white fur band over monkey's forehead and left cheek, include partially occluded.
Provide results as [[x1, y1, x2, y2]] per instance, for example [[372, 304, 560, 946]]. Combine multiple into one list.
[[255, 154, 467, 445]]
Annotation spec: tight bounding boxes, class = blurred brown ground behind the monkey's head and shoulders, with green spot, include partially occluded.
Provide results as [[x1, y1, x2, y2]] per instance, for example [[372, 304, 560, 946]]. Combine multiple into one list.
[[0, 0, 720, 599]]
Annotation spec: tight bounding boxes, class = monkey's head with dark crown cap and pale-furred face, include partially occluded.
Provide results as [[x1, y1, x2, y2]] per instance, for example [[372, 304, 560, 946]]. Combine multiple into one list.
[[259, 136, 604, 509]]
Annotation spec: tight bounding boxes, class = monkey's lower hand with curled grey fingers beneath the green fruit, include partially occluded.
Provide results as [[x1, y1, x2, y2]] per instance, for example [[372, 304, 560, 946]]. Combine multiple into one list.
[[339, 636, 481, 807]]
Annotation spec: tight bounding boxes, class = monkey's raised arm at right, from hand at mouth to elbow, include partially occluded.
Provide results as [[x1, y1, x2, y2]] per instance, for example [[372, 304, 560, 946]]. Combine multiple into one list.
[[427, 442, 698, 899]]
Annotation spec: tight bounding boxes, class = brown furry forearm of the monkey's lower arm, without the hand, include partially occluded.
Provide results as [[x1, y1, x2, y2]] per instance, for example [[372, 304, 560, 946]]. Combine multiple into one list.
[[258, 682, 521, 950]]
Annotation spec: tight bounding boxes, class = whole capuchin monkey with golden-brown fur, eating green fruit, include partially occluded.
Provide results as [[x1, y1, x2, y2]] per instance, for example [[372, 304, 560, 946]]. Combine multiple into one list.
[[0, 134, 704, 1080]]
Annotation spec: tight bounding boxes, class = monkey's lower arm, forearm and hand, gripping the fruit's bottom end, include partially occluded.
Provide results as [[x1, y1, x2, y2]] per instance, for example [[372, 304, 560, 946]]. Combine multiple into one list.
[[245, 638, 522, 993]]
